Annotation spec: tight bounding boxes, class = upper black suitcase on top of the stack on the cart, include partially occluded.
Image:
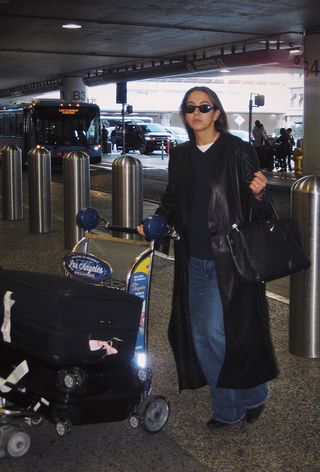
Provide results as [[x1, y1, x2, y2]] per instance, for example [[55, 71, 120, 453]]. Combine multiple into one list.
[[0, 270, 142, 365]]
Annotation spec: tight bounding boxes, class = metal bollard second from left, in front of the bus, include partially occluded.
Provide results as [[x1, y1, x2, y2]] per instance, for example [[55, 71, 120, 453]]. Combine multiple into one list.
[[28, 146, 52, 233]]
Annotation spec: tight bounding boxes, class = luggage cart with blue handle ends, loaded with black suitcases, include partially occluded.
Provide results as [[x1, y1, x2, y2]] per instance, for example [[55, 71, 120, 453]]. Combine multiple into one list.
[[0, 208, 179, 457]]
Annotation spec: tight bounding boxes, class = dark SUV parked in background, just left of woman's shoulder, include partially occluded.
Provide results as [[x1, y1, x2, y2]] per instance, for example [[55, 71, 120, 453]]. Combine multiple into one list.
[[115, 122, 176, 154]]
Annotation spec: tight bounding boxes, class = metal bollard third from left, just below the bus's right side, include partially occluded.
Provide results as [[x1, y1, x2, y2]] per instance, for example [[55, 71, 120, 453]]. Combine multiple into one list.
[[63, 151, 90, 249]]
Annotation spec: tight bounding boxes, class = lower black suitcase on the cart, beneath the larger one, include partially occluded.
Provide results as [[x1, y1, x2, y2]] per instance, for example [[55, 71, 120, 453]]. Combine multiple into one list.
[[0, 343, 144, 426]]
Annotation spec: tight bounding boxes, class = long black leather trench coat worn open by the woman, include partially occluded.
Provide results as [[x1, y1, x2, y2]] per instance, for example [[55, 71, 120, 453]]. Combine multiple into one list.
[[157, 134, 277, 390]]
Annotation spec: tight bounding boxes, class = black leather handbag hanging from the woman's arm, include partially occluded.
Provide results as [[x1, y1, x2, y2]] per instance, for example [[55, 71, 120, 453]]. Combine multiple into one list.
[[227, 205, 310, 283]]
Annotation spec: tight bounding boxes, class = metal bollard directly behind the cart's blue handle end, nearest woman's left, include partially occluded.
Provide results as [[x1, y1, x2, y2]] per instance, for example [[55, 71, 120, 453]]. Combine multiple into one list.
[[112, 155, 143, 239]]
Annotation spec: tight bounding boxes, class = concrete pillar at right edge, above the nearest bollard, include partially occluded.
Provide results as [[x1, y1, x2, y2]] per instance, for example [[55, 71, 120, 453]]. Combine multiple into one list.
[[303, 33, 320, 175]]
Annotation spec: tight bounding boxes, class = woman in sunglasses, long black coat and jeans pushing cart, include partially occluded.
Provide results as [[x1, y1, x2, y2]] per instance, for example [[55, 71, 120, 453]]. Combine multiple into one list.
[[140, 87, 277, 429]]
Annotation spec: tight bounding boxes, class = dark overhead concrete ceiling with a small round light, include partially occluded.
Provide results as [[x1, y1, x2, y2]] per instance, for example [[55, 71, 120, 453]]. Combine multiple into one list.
[[0, 0, 320, 98]]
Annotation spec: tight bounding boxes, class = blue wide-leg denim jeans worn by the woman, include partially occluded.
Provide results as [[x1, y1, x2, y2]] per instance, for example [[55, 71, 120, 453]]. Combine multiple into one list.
[[188, 257, 268, 424]]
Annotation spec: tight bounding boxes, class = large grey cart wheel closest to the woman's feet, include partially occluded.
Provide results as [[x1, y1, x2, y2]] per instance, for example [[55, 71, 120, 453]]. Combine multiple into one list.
[[141, 395, 170, 434]]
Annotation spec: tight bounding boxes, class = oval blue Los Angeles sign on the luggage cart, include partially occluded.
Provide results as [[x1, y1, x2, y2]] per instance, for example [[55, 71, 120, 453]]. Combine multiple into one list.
[[64, 253, 112, 283]]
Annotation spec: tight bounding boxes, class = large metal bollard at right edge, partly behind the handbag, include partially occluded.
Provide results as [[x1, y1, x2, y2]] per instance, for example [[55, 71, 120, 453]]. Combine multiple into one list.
[[289, 175, 320, 359]]
